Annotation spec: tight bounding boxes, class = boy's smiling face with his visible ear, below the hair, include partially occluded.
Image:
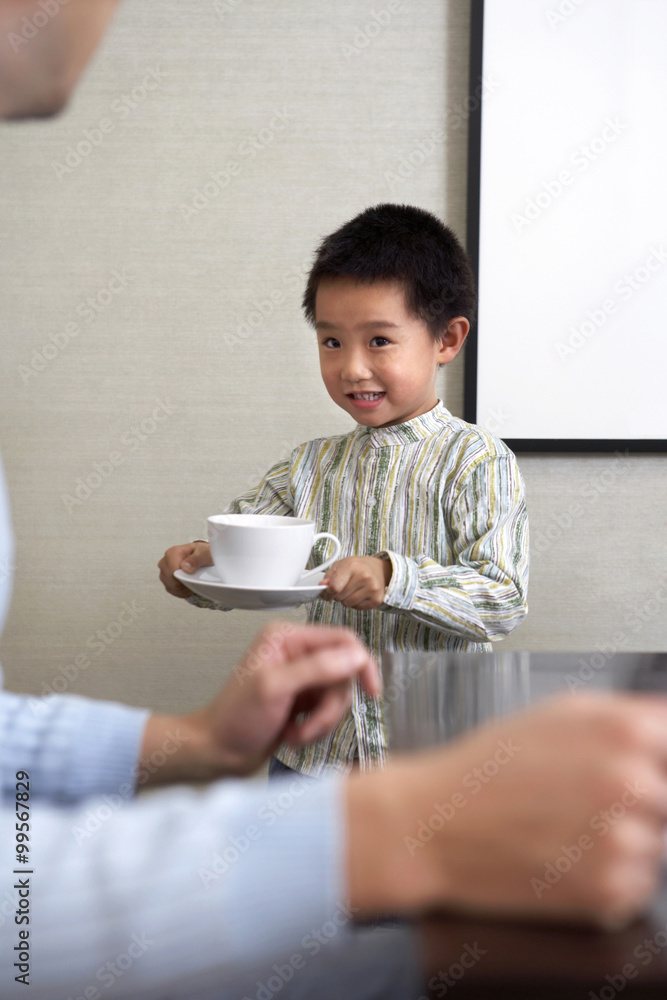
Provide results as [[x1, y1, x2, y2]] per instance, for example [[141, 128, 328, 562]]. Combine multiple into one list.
[[315, 278, 468, 427]]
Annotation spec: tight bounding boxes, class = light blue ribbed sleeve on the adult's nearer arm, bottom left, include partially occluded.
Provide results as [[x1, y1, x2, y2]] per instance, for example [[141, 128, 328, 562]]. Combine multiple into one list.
[[0, 752, 344, 1000]]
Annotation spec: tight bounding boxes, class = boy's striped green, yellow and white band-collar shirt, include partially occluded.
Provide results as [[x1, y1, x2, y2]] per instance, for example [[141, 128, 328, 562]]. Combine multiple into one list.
[[217, 402, 528, 775]]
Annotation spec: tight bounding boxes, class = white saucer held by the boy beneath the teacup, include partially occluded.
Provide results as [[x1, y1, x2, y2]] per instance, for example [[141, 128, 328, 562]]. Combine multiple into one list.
[[174, 566, 326, 611]]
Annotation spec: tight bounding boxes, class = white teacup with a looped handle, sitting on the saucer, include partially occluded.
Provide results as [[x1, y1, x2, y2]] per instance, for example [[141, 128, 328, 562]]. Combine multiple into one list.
[[208, 514, 341, 590]]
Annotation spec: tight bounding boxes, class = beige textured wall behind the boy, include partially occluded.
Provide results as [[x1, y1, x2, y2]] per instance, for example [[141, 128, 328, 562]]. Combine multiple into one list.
[[0, 0, 667, 710]]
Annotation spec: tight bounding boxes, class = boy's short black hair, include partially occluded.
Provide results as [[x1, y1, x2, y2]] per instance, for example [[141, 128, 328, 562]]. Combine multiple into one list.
[[302, 204, 475, 339]]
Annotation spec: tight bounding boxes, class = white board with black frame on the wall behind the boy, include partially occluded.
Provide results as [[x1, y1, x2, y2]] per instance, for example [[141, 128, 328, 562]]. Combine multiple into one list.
[[465, 0, 667, 451]]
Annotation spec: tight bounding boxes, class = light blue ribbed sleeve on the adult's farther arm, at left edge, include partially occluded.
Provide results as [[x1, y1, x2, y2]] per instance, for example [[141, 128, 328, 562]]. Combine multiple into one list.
[[0, 691, 148, 802]]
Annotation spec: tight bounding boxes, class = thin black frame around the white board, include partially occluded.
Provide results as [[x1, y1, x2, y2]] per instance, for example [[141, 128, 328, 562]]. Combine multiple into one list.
[[463, 0, 667, 454]]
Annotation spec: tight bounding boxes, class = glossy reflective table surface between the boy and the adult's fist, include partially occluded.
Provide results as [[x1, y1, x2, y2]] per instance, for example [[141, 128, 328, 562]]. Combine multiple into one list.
[[382, 648, 667, 752]]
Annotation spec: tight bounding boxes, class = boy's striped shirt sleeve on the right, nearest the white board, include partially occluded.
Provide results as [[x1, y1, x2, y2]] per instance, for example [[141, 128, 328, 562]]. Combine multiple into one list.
[[383, 455, 528, 642]]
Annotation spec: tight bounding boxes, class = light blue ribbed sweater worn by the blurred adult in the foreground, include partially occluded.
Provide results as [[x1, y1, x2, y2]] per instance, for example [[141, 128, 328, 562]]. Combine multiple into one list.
[[0, 467, 351, 1000]]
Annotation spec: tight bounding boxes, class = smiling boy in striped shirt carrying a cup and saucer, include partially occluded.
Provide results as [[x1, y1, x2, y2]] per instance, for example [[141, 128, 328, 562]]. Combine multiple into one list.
[[160, 205, 528, 776]]
